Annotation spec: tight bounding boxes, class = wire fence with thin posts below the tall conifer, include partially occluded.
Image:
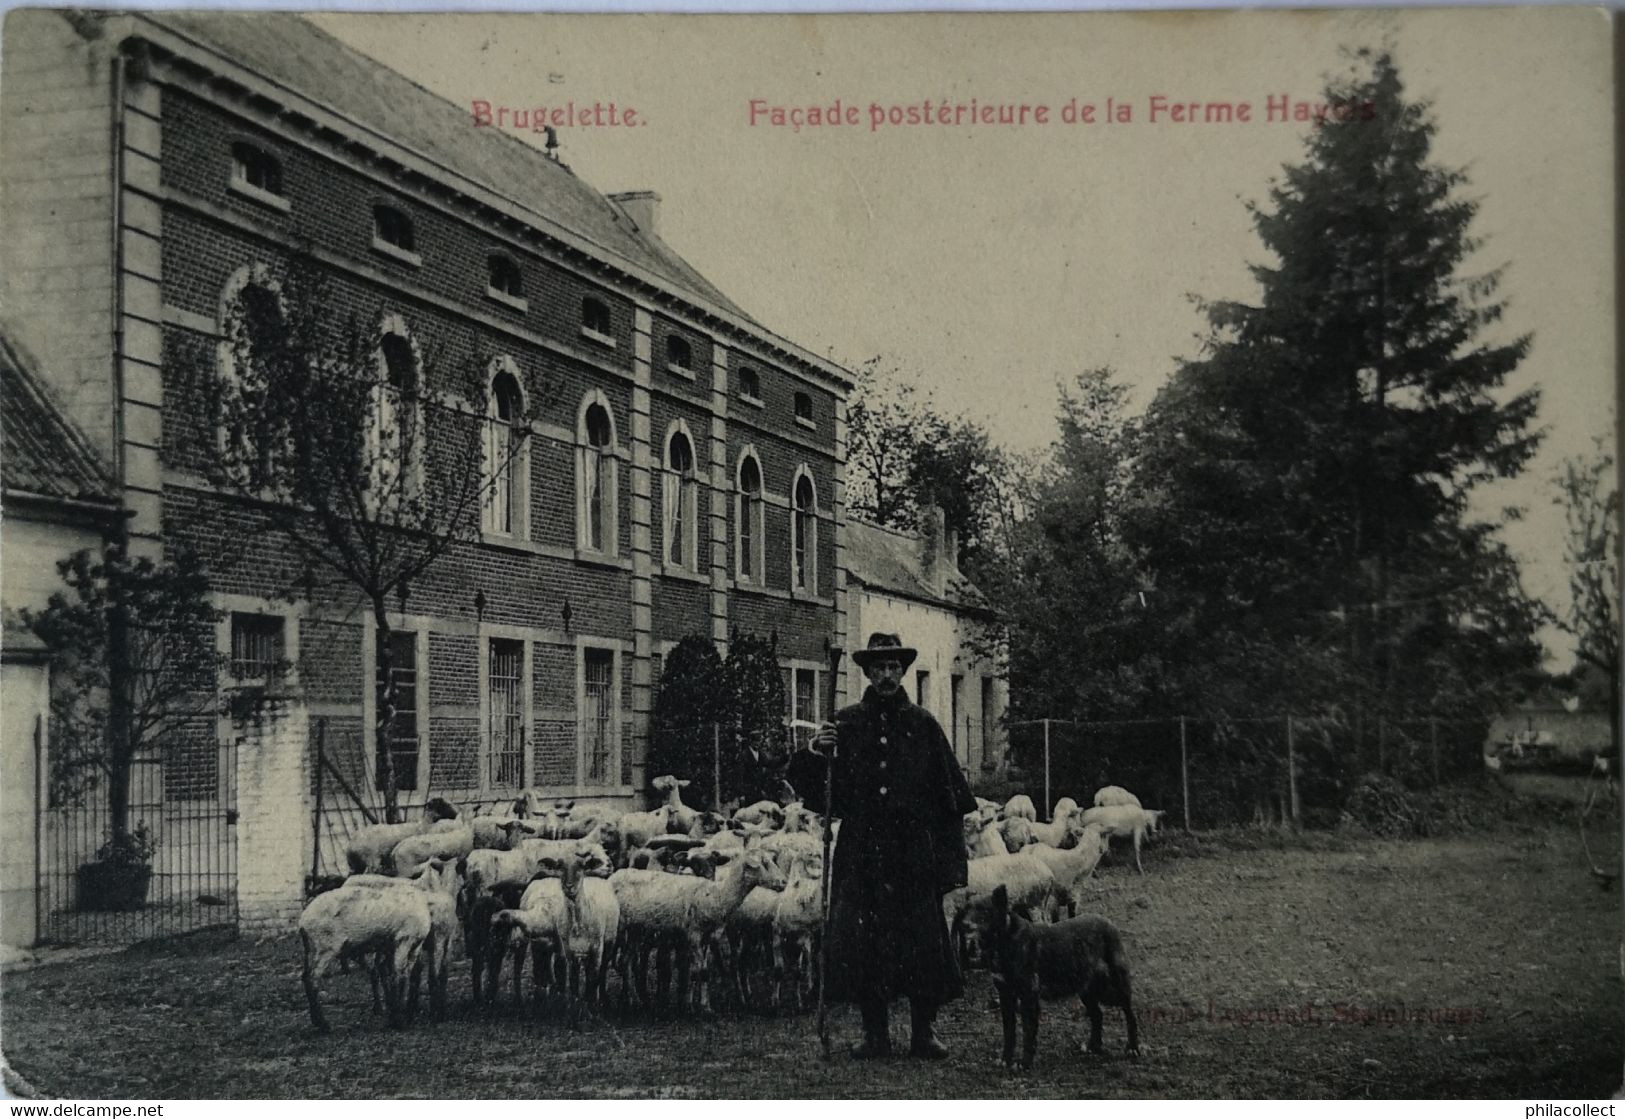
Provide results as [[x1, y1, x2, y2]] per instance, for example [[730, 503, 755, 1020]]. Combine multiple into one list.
[[1009, 715, 1487, 828]]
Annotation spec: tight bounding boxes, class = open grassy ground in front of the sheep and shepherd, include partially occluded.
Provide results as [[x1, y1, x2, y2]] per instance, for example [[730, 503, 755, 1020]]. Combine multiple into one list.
[[0, 823, 1625, 1098]]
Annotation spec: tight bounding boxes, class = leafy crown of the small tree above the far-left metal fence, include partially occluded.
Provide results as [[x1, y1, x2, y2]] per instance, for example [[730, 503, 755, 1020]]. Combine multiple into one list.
[[23, 544, 221, 849]]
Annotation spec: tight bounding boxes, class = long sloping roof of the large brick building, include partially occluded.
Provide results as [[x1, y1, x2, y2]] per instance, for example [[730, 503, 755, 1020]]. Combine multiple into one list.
[[140, 11, 756, 322]]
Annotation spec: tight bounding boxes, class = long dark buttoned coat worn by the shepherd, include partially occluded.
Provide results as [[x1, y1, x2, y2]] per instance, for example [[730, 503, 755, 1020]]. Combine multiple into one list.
[[790, 687, 977, 1004]]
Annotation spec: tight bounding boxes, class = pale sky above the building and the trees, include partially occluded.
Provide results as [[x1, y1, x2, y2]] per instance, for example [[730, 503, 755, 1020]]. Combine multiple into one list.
[[315, 8, 1615, 668]]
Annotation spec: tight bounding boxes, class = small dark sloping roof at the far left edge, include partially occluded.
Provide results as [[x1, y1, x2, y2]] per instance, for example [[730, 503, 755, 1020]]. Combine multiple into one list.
[[0, 323, 117, 505]]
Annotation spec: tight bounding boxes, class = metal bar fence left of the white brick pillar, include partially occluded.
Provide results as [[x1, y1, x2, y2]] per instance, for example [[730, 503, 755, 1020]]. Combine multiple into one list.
[[36, 742, 237, 945]]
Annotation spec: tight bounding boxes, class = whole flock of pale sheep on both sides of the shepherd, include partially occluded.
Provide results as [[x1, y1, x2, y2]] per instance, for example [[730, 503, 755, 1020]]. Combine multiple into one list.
[[299, 776, 1162, 1030]]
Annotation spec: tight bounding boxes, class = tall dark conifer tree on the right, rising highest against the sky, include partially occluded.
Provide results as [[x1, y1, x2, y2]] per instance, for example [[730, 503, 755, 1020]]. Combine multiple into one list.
[[1136, 52, 1539, 750]]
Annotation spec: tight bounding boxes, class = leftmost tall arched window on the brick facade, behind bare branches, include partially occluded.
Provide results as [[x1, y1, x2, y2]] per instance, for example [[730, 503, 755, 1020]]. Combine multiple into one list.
[[215, 265, 288, 489]]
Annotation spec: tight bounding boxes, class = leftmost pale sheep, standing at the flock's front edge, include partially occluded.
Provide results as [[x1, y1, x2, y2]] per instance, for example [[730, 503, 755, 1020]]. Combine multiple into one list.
[[297, 884, 434, 1033]]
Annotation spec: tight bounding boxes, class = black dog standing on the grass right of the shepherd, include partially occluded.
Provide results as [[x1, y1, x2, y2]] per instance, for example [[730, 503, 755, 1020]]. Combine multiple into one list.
[[991, 887, 1139, 1069]]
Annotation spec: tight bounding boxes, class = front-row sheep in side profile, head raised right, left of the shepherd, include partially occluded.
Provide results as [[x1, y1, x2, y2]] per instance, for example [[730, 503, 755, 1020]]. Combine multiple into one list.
[[609, 851, 785, 1007]]
